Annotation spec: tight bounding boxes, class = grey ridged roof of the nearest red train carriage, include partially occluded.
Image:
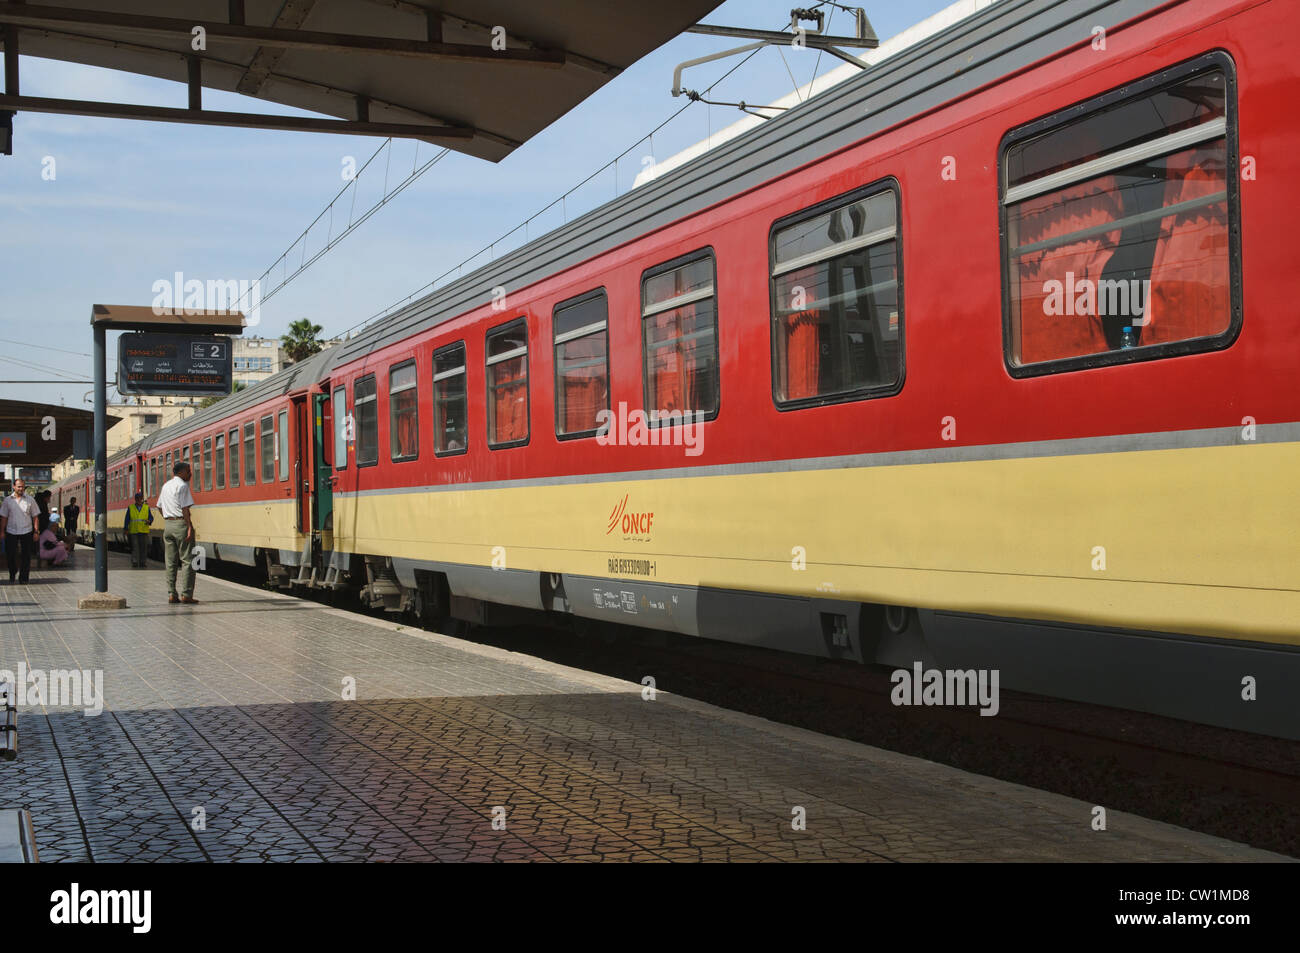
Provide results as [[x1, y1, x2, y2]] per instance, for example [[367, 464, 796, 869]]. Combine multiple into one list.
[[339, 0, 1165, 361]]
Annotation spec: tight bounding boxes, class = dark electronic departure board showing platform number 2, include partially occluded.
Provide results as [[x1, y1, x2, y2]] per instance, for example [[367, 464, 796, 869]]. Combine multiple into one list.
[[117, 334, 234, 395]]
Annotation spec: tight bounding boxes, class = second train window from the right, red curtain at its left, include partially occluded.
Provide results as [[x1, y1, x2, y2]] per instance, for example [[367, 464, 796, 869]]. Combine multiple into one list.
[[771, 181, 904, 407]]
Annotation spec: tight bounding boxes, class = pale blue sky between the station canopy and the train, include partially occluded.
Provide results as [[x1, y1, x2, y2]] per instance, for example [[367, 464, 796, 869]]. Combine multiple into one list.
[[0, 0, 949, 406]]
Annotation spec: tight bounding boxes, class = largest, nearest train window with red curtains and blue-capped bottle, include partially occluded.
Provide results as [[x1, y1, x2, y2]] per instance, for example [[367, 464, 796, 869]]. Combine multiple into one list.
[[1001, 53, 1240, 377]]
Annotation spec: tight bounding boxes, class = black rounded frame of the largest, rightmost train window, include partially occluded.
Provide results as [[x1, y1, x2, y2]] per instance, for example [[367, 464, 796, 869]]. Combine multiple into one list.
[[997, 49, 1243, 380]]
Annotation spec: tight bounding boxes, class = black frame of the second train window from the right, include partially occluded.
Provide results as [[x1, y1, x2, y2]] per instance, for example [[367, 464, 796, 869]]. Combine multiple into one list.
[[764, 176, 907, 413]]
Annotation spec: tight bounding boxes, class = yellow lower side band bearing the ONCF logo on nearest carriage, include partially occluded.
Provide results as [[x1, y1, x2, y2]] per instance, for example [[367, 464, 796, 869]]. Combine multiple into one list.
[[319, 443, 1300, 644]]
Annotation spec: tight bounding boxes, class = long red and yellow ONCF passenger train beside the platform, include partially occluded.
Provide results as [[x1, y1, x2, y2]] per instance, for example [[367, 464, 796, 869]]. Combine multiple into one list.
[[58, 0, 1300, 737]]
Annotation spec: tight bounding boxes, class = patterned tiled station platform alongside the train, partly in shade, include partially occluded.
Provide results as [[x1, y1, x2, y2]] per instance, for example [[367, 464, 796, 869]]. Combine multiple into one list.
[[0, 549, 1287, 862]]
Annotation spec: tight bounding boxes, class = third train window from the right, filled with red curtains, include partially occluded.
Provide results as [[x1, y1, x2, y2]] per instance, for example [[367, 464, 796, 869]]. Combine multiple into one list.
[[641, 252, 718, 425]]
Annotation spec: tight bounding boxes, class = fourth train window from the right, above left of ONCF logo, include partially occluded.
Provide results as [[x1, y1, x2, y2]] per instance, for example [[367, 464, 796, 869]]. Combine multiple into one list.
[[551, 289, 610, 437]]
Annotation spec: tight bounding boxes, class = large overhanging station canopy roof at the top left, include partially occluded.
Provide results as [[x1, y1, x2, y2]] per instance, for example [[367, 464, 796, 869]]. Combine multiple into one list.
[[0, 0, 719, 161]]
